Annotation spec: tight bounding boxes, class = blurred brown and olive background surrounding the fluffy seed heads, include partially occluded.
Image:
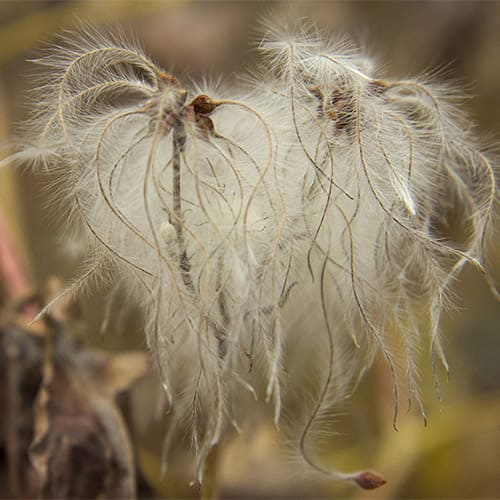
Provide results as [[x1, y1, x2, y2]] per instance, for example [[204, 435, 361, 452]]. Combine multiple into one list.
[[0, 0, 500, 498]]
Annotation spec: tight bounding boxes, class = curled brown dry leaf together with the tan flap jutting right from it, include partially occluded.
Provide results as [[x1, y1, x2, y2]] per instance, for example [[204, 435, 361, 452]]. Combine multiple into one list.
[[30, 322, 147, 498]]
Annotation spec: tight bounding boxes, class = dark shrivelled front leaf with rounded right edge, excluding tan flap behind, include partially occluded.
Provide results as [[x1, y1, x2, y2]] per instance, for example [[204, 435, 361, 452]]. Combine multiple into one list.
[[31, 356, 135, 498]]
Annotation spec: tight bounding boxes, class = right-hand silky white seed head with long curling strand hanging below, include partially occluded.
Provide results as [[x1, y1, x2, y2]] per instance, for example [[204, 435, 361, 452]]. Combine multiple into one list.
[[259, 23, 496, 478]]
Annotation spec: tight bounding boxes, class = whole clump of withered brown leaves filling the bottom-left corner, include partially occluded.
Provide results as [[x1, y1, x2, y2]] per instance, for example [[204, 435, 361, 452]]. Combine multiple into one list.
[[0, 284, 147, 498]]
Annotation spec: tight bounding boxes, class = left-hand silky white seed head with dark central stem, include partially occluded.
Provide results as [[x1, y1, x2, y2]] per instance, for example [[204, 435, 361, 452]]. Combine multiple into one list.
[[17, 26, 291, 479]]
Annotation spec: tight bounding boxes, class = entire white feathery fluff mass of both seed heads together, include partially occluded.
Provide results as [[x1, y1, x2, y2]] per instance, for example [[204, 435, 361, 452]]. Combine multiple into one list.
[[10, 24, 495, 488]]
